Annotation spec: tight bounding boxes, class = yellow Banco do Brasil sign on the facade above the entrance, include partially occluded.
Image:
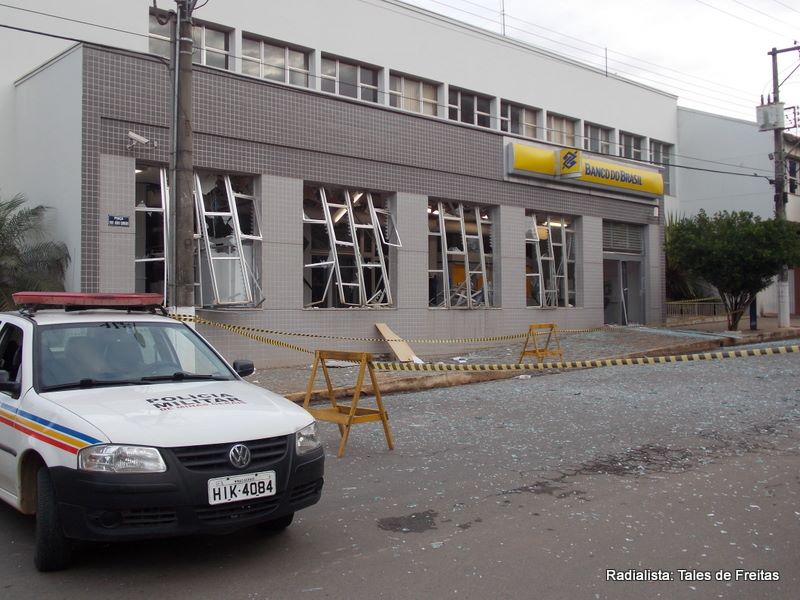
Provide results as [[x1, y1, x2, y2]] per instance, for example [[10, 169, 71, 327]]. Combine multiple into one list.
[[507, 143, 664, 197]]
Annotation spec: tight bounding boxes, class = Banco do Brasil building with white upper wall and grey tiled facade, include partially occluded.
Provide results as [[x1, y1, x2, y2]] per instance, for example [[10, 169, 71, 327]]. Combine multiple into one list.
[[0, 0, 680, 364]]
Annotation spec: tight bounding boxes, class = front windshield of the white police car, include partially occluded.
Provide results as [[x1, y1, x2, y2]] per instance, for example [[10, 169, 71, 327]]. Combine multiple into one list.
[[35, 321, 234, 391]]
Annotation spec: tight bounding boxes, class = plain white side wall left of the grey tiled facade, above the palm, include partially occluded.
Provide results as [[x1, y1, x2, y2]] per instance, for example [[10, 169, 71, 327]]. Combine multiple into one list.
[[14, 47, 83, 290]]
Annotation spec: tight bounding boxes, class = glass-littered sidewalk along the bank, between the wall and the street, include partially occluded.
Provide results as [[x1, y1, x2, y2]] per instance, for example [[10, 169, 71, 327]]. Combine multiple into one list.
[[248, 317, 800, 402]]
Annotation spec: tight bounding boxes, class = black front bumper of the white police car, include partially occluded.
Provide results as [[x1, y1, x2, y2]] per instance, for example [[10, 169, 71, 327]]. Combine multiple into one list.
[[51, 436, 325, 541]]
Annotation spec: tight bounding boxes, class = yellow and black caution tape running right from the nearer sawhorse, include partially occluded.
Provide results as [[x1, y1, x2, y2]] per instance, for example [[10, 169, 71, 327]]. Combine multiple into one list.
[[372, 345, 800, 372]]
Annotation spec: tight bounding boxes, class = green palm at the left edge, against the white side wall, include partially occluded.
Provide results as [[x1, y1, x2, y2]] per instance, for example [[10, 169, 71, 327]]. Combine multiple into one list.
[[0, 194, 70, 310]]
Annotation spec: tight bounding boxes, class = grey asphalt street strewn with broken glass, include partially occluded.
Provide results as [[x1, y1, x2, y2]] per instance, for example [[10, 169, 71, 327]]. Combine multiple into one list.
[[0, 340, 800, 600]]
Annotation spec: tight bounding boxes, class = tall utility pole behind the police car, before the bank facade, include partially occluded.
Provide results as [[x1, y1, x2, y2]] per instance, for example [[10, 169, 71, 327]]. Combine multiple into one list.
[[172, 0, 197, 309]]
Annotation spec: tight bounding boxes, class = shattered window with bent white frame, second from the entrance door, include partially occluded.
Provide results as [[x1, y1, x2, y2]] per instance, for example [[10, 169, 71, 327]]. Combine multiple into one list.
[[428, 200, 494, 308]]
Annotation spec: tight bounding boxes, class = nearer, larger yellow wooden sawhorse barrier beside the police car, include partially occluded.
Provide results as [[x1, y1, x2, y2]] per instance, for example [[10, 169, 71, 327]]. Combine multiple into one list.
[[303, 350, 394, 458]]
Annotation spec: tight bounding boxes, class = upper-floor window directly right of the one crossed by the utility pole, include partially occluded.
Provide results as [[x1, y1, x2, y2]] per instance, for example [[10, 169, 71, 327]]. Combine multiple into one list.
[[242, 36, 308, 87]]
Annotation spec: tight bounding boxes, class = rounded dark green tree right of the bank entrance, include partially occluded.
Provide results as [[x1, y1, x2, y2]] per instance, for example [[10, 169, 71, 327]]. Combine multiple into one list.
[[666, 210, 800, 330]]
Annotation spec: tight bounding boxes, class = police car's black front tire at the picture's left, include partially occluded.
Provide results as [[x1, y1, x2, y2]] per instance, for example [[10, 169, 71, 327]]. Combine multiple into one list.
[[33, 467, 72, 572]]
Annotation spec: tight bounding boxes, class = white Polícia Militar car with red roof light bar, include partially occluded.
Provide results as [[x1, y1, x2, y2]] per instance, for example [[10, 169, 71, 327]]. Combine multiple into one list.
[[0, 292, 324, 571]]
